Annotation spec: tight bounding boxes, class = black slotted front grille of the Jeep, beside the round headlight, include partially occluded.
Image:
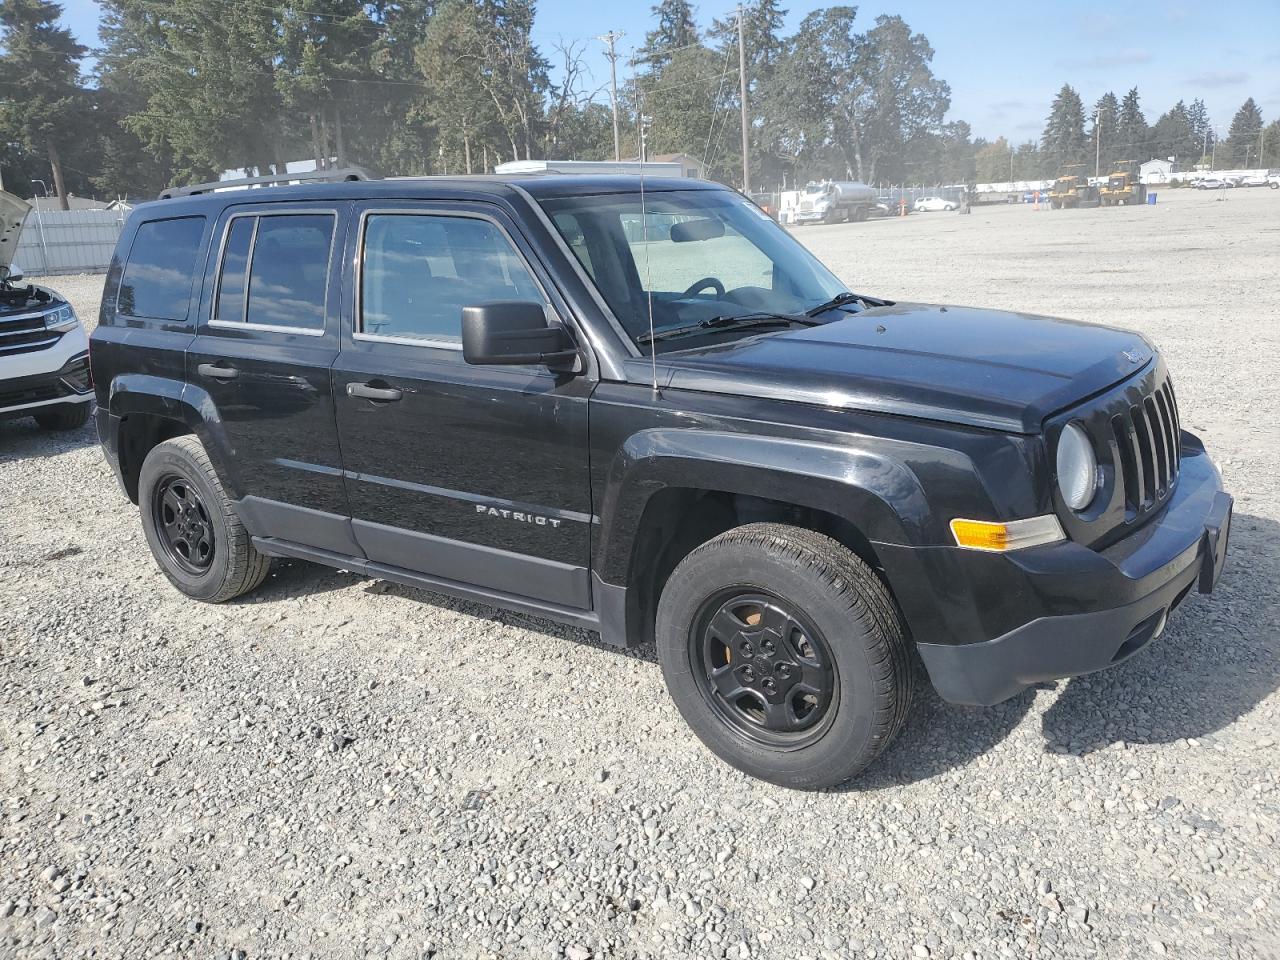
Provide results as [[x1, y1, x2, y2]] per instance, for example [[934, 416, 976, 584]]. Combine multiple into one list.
[[1111, 378, 1180, 518]]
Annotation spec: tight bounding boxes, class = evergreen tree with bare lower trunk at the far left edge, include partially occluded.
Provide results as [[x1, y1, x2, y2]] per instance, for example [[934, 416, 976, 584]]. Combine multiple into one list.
[[0, 0, 88, 210]]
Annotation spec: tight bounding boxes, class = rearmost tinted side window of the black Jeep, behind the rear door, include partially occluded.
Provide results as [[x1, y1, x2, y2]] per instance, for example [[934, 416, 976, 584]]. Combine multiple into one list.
[[116, 216, 205, 323]]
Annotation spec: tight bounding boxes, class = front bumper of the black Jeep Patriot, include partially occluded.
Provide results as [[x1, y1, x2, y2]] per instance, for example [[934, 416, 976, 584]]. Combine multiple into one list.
[[891, 434, 1233, 705]]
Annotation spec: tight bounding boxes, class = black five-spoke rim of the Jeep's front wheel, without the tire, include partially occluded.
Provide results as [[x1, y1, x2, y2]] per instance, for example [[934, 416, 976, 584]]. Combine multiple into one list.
[[689, 590, 838, 746]]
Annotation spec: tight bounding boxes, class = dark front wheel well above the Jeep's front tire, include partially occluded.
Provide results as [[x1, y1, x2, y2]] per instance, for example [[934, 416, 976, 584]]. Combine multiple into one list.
[[627, 488, 884, 644]]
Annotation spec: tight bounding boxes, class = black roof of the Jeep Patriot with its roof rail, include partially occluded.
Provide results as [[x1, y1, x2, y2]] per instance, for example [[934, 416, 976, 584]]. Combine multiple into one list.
[[138, 173, 728, 217]]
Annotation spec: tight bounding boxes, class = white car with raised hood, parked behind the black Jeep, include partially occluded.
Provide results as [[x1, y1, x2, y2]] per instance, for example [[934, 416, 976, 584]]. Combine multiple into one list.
[[0, 192, 93, 430]]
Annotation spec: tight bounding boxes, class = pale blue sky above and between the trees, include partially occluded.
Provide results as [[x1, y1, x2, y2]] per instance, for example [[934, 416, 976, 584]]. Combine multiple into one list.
[[63, 0, 1280, 142]]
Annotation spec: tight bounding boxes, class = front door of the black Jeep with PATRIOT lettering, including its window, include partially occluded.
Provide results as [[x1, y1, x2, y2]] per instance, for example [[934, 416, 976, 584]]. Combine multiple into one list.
[[333, 202, 593, 609]]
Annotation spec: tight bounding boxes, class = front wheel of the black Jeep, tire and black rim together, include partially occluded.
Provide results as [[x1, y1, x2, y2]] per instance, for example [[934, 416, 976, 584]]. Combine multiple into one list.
[[655, 524, 914, 790]]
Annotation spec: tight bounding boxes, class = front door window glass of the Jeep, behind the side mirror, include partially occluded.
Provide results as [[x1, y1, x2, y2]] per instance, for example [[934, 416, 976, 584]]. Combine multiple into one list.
[[360, 214, 545, 342]]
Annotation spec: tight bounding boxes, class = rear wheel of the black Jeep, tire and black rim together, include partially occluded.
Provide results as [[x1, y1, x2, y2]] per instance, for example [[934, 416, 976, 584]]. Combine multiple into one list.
[[138, 436, 271, 603]]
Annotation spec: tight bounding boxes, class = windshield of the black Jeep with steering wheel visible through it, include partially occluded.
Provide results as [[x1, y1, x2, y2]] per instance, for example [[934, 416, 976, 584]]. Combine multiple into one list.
[[541, 189, 845, 352]]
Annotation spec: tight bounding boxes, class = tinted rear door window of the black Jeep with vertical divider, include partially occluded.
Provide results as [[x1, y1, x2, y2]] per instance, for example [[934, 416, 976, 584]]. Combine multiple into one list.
[[214, 214, 335, 330]]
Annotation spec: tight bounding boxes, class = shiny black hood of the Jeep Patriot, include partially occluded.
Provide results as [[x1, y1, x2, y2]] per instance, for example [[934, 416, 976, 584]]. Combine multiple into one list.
[[658, 303, 1155, 434]]
